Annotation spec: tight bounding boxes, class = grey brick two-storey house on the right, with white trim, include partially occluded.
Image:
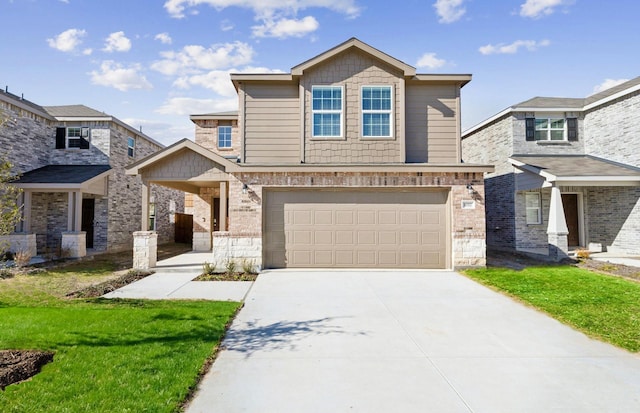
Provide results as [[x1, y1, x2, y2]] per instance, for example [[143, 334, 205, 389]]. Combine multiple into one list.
[[462, 77, 640, 259]]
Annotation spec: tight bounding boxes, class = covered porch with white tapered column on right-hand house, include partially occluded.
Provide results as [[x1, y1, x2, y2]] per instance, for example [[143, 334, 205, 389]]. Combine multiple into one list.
[[509, 155, 640, 261]]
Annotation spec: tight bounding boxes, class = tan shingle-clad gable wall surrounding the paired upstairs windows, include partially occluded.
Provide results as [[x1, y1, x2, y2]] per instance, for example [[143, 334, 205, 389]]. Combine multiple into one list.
[[301, 48, 404, 163]]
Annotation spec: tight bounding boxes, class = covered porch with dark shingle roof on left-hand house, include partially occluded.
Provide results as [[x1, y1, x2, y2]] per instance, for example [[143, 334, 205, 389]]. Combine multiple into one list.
[[3, 165, 112, 258]]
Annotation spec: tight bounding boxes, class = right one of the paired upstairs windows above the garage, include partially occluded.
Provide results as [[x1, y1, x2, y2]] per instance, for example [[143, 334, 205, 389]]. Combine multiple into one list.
[[362, 86, 392, 138]]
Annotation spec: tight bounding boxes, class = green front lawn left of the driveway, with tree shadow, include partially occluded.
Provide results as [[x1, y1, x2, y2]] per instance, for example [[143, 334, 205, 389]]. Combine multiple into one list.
[[0, 249, 239, 413]]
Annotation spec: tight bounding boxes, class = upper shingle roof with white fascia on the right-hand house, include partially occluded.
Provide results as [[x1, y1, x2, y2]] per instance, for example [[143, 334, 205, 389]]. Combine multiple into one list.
[[462, 76, 640, 139]]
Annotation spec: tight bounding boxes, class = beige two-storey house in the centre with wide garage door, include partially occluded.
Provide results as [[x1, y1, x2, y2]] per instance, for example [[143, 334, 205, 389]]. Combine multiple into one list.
[[127, 38, 493, 268]]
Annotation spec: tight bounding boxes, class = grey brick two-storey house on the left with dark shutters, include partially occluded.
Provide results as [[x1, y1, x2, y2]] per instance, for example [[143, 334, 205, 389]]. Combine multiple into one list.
[[0, 91, 184, 257]]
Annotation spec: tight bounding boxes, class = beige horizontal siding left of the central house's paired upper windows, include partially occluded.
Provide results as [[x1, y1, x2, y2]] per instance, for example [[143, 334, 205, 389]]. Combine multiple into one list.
[[243, 83, 300, 164]]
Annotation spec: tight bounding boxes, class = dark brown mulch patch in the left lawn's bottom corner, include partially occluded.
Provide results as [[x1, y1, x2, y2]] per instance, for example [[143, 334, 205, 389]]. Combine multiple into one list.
[[0, 350, 53, 390]]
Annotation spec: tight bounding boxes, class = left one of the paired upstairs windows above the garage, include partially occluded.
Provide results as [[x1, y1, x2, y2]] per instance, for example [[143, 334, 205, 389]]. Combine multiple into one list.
[[311, 86, 343, 138]]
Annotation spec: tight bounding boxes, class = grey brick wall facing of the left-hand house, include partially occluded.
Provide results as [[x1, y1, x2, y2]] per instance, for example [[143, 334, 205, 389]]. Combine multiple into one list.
[[0, 92, 184, 253]]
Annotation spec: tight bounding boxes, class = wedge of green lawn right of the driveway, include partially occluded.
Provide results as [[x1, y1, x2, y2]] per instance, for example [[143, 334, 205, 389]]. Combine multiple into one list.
[[465, 266, 640, 352]]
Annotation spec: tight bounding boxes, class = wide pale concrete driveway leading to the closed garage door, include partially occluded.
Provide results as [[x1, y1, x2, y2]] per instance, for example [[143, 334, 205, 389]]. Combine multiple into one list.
[[187, 270, 640, 413]]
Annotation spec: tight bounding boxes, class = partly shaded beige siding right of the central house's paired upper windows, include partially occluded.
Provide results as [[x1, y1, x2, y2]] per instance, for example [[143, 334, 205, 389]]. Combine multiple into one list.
[[405, 83, 459, 163]]
